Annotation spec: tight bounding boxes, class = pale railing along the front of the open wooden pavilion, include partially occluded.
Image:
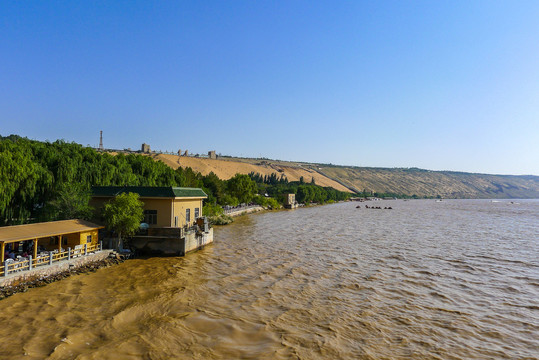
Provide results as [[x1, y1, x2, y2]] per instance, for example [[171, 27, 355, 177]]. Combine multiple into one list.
[[0, 242, 103, 276]]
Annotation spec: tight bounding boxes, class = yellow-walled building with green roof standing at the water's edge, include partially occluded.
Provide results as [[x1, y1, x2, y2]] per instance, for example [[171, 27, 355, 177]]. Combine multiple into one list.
[[90, 186, 208, 227]]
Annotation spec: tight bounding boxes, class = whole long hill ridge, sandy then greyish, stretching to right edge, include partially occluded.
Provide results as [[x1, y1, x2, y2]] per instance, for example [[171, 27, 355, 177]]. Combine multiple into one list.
[[153, 154, 539, 199]]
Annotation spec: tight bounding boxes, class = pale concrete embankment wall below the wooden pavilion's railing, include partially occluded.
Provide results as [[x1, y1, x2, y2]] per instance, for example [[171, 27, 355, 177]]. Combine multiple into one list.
[[0, 250, 112, 286]]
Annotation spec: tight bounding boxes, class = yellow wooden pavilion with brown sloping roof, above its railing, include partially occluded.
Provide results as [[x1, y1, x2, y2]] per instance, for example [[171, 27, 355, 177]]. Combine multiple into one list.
[[0, 220, 103, 263]]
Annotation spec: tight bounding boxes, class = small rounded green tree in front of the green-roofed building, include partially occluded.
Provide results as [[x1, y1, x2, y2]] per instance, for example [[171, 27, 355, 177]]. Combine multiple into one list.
[[103, 193, 144, 241]]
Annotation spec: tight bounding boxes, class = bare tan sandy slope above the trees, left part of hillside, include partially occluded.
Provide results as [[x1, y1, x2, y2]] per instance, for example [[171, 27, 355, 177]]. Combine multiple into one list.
[[152, 154, 350, 192]]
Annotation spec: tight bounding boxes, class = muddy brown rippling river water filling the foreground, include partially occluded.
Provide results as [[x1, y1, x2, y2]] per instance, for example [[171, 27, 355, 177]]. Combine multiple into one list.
[[0, 200, 539, 359]]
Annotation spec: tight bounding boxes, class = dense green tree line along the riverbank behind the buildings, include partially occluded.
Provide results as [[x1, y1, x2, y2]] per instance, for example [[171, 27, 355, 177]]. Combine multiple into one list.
[[0, 135, 350, 225]]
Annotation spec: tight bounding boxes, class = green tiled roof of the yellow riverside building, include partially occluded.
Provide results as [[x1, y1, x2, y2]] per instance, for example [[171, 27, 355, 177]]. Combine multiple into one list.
[[92, 186, 208, 198]]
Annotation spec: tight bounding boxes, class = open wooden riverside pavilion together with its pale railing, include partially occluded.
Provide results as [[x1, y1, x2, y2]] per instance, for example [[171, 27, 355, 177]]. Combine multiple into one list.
[[0, 220, 103, 276]]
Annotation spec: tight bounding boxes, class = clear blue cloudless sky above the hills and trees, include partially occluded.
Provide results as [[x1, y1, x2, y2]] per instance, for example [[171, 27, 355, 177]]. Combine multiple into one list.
[[0, 0, 539, 175]]
